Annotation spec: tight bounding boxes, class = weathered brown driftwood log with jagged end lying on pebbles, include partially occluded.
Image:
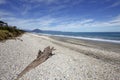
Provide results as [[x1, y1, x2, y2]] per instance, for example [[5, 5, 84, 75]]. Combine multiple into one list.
[[16, 46, 55, 80]]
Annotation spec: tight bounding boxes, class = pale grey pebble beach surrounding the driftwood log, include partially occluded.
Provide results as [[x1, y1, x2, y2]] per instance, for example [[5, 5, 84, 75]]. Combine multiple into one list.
[[0, 33, 120, 80]]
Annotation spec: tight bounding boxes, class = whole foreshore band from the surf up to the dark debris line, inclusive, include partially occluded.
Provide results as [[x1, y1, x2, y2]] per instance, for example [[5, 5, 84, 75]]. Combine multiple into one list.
[[38, 32, 120, 66]]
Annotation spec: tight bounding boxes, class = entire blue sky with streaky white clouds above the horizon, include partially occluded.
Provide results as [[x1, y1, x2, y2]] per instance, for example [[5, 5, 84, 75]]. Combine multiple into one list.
[[0, 0, 120, 32]]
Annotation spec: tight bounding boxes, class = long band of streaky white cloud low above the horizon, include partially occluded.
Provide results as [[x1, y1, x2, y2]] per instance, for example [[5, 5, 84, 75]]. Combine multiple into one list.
[[3, 12, 120, 31]]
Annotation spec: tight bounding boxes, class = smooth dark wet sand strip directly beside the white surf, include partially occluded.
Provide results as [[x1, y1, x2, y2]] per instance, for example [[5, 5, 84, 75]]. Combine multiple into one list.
[[36, 34, 120, 53]]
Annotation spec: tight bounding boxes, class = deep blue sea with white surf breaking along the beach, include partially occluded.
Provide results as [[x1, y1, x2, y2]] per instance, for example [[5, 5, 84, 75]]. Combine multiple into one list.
[[37, 32, 120, 44]]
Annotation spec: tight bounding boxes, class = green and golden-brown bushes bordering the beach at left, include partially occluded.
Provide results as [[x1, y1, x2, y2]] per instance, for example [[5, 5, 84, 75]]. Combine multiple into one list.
[[0, 21, 24, 41]]
